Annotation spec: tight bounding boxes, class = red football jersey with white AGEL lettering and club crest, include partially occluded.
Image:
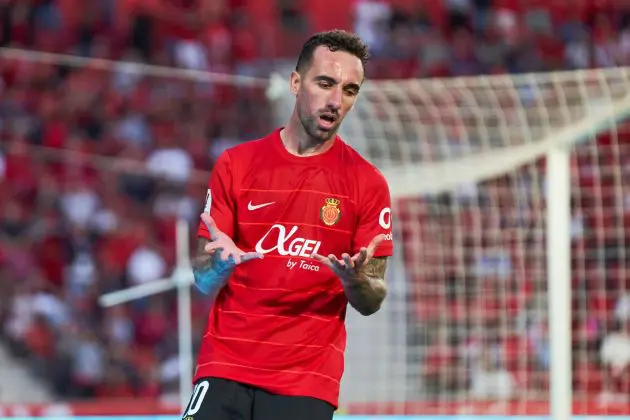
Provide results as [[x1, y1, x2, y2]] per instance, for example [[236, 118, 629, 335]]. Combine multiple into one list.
[[195, 129, 393, 407]]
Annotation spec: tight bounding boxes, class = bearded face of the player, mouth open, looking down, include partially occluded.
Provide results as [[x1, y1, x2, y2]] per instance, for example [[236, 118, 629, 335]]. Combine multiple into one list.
[[291, 46, 364, 142]]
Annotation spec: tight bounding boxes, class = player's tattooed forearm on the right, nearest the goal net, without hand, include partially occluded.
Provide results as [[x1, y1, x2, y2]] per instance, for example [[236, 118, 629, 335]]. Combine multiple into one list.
[[344, 257, 387, 316]]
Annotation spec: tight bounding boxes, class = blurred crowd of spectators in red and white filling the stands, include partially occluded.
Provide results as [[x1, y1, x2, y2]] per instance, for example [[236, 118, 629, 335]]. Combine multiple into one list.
[[0, 0, 630, 406]]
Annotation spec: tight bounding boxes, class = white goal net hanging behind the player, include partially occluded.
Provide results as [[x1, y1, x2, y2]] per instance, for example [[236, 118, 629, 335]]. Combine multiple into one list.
[[271, 69, 630, 415]]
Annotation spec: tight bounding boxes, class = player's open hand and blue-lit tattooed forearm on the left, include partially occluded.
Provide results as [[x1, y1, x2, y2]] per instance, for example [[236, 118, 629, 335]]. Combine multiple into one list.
[[193, 213, 263, 294]]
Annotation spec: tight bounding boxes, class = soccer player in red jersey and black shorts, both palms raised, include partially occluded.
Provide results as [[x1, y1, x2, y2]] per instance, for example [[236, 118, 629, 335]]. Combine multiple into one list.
[[184, 30, 393, 420]]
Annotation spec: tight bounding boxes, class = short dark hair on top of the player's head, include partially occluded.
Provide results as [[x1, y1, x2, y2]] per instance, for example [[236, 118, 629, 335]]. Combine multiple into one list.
[[295, 29, 370, 74]]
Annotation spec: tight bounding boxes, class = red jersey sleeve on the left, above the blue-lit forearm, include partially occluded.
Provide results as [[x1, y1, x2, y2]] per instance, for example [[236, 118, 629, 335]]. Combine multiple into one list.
[[197, 152, 236, 239]]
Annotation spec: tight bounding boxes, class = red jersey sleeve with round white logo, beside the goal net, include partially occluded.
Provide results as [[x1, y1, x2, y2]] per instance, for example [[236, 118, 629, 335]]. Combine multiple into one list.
[[352, 168, 394, 257]]
